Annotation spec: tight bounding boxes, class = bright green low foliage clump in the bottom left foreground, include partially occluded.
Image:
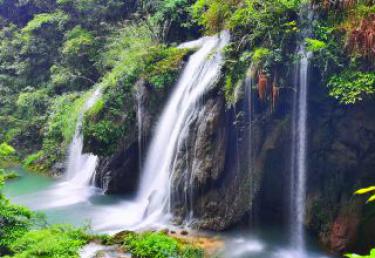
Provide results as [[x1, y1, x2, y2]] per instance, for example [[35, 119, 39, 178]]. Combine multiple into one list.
[[4, 225, 90, 258]]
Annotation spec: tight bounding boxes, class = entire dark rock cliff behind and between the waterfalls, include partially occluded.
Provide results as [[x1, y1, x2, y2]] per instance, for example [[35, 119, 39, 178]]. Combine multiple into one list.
[[92, 67, 375, 253]]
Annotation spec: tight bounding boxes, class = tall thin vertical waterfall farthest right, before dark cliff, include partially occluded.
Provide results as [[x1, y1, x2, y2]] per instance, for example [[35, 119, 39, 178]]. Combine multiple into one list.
[[290, 5, 312, 255]]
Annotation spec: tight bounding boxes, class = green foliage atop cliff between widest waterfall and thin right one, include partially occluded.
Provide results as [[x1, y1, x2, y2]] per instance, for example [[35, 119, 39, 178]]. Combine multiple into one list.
[[200, 0, 302, 105]]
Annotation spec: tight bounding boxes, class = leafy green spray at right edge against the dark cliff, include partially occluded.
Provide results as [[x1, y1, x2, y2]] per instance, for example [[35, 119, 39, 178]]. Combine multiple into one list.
[[328, 70, 375, 104]]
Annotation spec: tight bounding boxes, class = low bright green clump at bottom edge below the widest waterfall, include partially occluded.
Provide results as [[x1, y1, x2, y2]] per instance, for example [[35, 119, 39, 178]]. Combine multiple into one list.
[[124, 232, 203, 258]]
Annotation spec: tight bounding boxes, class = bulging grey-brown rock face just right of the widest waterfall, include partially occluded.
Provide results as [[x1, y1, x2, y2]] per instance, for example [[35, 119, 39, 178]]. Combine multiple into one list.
[[171, 79, 289, 230]]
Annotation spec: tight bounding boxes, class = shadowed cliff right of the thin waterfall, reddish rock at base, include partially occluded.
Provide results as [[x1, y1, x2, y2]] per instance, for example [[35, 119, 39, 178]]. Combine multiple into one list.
[[307, 91, 375, 253]]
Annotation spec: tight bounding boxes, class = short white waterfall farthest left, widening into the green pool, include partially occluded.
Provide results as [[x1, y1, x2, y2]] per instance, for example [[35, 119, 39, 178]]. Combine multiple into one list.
[[66, 87, 101, 186]]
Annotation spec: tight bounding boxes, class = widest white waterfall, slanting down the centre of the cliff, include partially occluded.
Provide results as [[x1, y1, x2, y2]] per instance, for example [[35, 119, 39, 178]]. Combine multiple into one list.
[[137, 31, 230, 226]]
